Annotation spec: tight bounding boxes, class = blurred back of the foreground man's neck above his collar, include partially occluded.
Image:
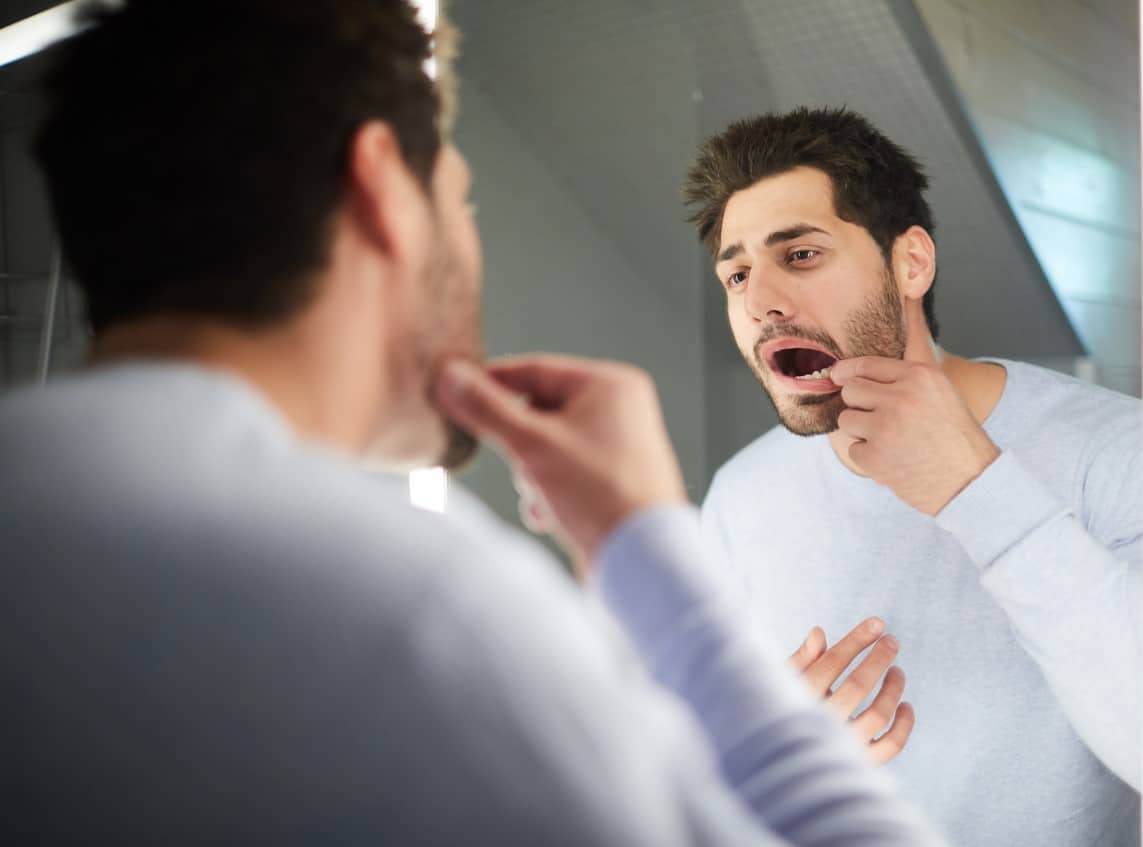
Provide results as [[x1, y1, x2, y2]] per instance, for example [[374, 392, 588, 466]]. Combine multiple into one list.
[[89, 315, 384, 453]]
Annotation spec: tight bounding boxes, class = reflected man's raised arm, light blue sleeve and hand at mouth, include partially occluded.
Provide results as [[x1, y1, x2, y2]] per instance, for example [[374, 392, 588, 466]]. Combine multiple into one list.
[[830, 357, 1143, 790]]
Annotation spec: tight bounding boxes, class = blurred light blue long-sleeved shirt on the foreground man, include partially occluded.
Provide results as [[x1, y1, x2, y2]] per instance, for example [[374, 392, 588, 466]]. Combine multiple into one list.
[[0, 363, 936, 847]]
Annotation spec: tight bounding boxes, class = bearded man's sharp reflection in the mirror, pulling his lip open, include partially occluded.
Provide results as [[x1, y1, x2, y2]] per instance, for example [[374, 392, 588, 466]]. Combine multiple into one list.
[[687, 109, 1143, 847]]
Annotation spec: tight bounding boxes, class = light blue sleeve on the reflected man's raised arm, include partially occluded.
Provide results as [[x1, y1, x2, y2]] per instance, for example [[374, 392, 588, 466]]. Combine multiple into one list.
[[937, 448, 1143, 790]]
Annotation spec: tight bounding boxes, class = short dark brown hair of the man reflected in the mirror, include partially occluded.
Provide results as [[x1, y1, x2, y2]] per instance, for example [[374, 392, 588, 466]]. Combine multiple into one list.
[[684, 107, 937, 339]]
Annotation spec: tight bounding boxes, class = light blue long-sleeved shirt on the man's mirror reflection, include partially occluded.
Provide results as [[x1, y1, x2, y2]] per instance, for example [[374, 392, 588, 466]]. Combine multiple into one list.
[[703, 361, 1143, 847]]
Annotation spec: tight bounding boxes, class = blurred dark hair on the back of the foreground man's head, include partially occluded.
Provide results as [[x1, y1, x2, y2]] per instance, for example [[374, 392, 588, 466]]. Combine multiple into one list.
[[37, 0, 440, 331]]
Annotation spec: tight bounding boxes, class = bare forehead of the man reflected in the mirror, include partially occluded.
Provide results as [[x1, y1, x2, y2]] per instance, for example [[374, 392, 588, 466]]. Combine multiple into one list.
[[719, 168, 842, 246]]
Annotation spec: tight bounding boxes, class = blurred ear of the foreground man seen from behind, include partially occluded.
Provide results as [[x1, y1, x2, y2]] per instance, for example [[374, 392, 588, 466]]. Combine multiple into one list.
[[346, 120, 427, 258]]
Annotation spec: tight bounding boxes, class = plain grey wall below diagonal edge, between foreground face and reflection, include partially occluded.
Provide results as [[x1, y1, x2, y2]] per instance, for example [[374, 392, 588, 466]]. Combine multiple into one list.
[[457, 82, 705, 521]]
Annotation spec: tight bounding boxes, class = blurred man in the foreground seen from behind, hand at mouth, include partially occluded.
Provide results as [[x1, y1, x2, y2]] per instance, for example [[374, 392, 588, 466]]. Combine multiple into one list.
[[0, 0, 934, 847]]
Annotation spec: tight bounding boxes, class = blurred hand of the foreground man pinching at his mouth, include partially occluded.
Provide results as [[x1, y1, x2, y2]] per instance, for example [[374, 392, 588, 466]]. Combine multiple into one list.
[[434, 355, 687, 576]]
